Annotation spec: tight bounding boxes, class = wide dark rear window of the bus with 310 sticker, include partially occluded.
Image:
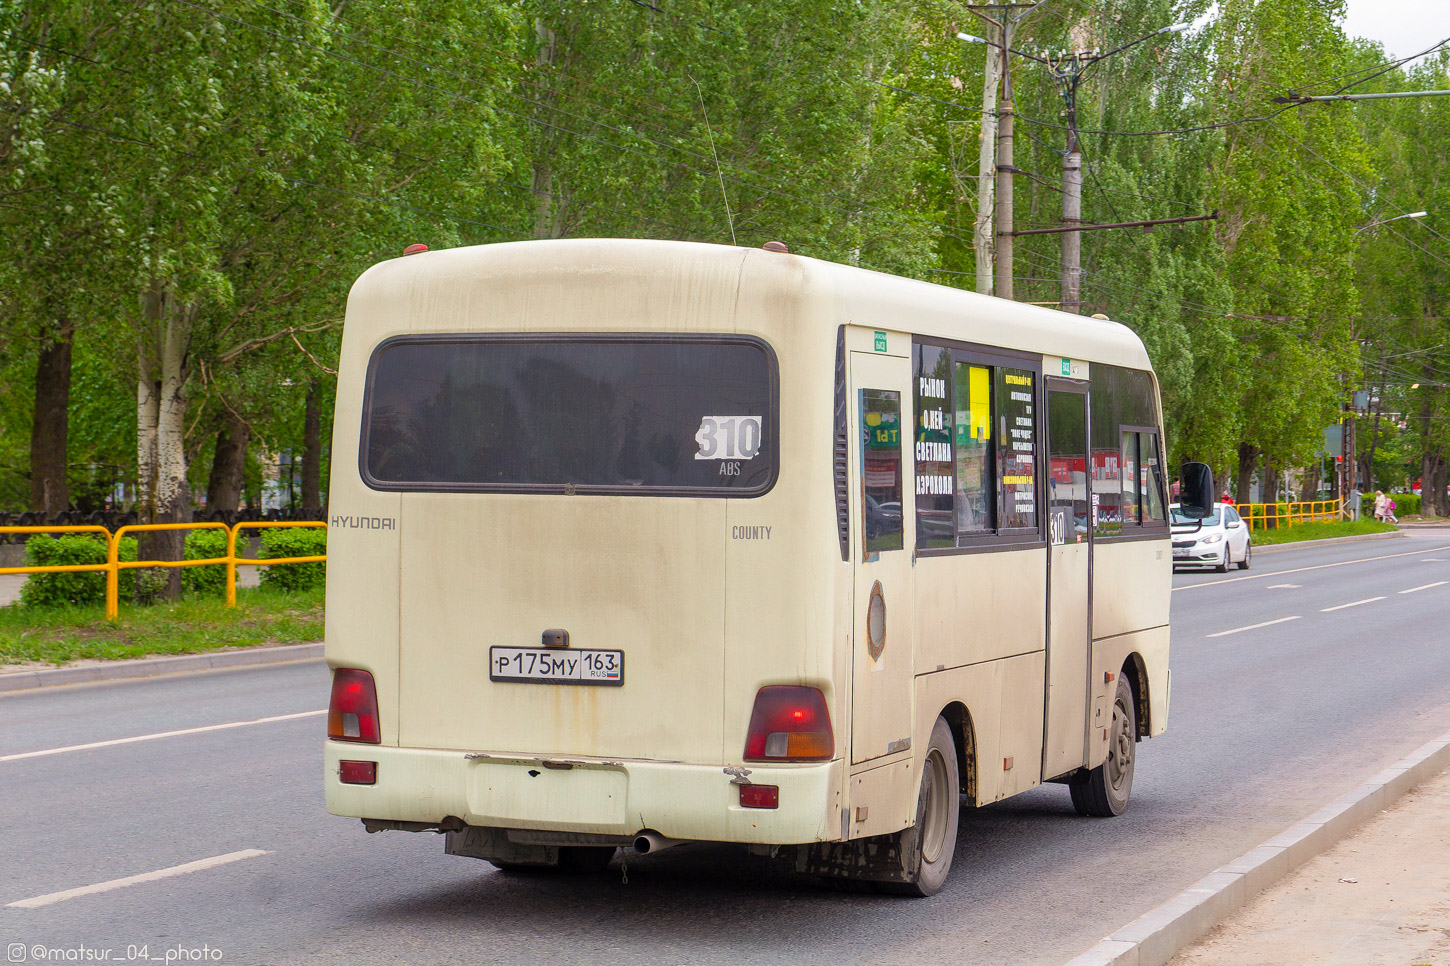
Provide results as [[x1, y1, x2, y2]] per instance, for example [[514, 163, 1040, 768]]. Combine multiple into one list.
[[361, 335, 779, 496]]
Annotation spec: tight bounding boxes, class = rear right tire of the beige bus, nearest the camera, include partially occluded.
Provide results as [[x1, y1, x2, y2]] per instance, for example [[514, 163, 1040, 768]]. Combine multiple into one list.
[[876, 718, 961, 898]]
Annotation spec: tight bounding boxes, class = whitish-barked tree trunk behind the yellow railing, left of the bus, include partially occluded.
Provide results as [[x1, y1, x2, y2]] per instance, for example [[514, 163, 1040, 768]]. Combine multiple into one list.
[[136, 284, 194, 600]]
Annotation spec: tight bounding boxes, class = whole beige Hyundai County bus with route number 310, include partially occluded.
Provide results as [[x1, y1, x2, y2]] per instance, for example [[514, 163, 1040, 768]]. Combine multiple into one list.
[[325, 239, 1171, 895]]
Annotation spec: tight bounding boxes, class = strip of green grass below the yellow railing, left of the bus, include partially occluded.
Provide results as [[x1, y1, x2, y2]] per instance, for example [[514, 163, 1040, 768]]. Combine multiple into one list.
[[0, 587, 323, 664]]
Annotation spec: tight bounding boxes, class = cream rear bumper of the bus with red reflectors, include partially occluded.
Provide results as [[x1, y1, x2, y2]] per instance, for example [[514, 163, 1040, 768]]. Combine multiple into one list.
[[323, 741, 842, 846]]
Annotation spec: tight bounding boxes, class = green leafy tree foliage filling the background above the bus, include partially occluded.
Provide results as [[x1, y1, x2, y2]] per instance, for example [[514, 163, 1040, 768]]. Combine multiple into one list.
[[0, 0, 1450, 519]]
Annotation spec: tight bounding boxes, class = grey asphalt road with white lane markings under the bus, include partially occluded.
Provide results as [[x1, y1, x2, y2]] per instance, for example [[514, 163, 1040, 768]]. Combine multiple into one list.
[[0, 529, 1450, 965]]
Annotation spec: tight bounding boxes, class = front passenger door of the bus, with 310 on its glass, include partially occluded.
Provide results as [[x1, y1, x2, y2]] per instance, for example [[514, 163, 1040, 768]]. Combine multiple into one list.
[[1043, 381, 1092, 782]]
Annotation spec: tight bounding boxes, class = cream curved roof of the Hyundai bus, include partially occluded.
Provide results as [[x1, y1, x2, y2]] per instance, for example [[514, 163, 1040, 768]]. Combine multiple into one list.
[[348, 238, 1151, 368]]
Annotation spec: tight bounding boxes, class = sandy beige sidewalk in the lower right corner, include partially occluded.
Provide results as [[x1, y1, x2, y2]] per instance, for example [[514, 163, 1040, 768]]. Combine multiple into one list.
[[1169, 770, 1450, 966]]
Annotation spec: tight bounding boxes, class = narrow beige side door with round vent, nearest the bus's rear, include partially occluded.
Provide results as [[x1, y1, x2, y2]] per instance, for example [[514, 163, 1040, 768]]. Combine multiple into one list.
[[847, 352, 915, 763]]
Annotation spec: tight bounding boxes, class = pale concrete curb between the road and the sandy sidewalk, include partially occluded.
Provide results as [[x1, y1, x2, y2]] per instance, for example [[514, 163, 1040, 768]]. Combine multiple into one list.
[[1067, 732, 1450, 966]]
